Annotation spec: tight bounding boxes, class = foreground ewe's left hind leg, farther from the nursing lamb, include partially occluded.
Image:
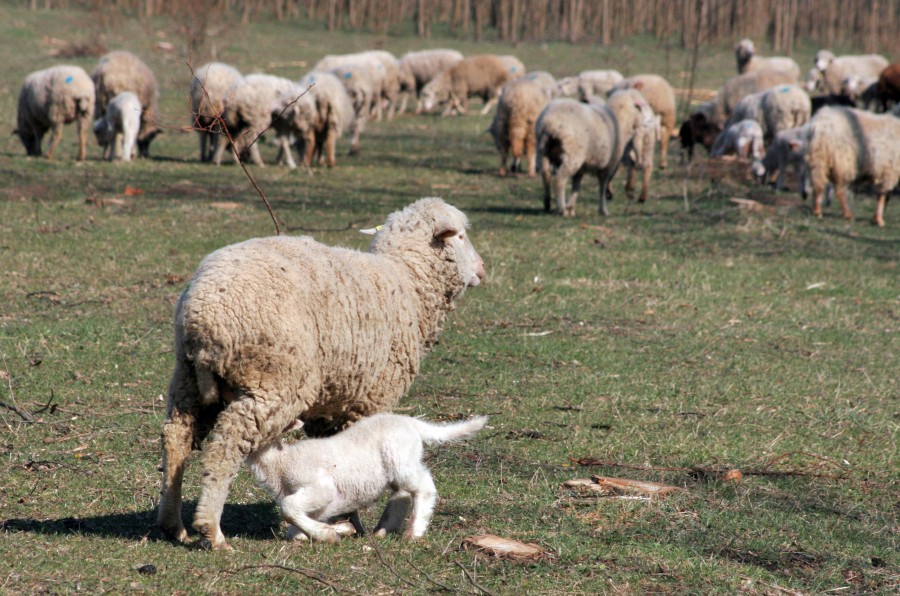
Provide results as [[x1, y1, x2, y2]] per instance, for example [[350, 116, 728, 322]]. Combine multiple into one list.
[[157, 360, 200, 542]]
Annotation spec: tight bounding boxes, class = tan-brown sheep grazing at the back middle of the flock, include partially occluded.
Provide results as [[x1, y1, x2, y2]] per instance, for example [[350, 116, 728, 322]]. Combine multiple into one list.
[[422, 54, 525, 116]]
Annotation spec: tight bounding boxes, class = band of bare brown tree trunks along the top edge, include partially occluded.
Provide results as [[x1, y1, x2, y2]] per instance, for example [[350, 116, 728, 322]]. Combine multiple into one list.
[[24, 0, 900, 54]]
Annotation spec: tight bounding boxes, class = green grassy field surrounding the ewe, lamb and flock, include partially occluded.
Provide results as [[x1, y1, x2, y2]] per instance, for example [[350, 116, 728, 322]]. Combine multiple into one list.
[[0, 3, 900, 594]]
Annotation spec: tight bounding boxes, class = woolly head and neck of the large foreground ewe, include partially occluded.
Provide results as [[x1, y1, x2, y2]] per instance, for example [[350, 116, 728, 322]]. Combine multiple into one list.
[[369, 197, 485, 298]]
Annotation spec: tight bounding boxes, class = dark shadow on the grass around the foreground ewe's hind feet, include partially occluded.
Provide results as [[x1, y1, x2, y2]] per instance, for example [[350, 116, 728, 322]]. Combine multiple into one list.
[[0, 501, 279, 541]]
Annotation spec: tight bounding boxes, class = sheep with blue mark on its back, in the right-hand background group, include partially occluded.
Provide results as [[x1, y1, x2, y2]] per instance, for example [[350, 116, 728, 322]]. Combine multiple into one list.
[[728, 85, 812, 141]]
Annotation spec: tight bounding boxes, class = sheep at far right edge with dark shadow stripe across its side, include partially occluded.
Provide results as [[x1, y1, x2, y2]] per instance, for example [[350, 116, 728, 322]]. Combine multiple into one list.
[[806, 107, 900, 227]]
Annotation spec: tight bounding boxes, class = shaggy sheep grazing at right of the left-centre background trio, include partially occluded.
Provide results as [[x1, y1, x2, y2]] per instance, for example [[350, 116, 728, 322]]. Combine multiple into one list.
[[293, 71, 362, 168]]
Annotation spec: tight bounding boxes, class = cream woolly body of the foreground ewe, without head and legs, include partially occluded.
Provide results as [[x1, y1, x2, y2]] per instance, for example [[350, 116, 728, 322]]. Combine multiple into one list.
[[176, 236, 421, 418]]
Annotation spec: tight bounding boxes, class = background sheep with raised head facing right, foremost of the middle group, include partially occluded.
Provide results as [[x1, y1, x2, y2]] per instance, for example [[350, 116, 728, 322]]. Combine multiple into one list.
[[535, 89, 654, 216]]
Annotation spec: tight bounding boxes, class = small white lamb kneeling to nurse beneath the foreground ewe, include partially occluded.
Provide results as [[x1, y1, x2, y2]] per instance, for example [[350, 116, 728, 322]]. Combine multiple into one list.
[[247, 414, 487, 542]]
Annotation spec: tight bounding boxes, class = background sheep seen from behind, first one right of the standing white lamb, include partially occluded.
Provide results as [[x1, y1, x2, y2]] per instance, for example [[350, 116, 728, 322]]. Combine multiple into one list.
[[191, 62, 242, 162]]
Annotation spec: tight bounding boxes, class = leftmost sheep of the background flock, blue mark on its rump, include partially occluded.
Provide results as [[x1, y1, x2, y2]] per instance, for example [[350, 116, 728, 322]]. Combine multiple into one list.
[[15, 66, 94, 161]]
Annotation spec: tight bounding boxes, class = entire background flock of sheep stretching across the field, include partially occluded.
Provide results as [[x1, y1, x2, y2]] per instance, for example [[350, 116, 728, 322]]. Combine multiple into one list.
[[17, 39, 900, 226]]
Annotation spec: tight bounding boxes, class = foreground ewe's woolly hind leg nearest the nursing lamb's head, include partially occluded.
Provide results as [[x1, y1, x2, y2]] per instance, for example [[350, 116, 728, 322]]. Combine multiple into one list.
[[194, 393, 305, 550]]
